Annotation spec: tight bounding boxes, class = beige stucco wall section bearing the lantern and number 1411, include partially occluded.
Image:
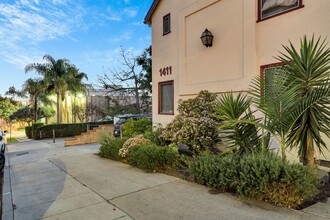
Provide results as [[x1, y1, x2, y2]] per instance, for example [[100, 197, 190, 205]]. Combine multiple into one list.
[[152, 0, 257, 124]]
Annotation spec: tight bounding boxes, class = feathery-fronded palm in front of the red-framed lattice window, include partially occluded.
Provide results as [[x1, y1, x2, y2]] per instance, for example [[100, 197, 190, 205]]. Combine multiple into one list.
[[250, 67, 299, 160]]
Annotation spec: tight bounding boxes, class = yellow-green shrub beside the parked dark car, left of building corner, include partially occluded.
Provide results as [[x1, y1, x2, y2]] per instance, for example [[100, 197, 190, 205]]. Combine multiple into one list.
[[122, 118, 152, 138]]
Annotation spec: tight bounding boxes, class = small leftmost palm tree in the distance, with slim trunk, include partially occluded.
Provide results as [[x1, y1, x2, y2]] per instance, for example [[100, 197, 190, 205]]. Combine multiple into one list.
[[21, 78, 47, 122]]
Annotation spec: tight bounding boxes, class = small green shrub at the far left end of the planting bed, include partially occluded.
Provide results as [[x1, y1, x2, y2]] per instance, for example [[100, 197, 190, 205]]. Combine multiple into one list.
[[99, 136, 127, 160]]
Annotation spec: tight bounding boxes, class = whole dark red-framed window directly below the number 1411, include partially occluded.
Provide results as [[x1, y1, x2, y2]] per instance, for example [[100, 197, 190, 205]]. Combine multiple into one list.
[[158, 80, 174, 115]]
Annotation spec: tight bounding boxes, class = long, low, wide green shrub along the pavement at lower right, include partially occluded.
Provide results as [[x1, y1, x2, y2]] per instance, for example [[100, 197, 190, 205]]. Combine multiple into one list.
[[189, 153, 320, 207]]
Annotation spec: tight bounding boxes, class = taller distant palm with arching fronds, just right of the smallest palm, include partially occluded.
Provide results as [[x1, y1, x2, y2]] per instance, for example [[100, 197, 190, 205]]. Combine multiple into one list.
[[25, 55, 84, 124]]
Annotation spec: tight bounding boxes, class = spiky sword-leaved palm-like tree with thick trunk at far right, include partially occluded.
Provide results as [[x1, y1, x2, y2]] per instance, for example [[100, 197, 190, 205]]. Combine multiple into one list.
[[278, 36, 330, 166]]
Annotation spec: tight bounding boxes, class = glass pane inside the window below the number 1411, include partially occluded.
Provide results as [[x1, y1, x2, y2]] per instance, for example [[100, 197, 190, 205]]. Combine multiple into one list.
[[160, 83, 173, 113]]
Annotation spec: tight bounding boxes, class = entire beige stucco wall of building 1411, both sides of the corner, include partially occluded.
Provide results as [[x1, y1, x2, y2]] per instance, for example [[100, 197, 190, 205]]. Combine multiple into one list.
[[151, 0, 330, 159]]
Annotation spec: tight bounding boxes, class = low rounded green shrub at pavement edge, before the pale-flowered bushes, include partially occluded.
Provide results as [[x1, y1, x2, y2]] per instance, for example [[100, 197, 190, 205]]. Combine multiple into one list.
[[128, 144, 178, 171]]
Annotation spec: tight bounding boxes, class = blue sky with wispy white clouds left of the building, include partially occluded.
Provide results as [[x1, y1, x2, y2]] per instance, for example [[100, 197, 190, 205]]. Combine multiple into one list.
[[0, 0, 152, 95]]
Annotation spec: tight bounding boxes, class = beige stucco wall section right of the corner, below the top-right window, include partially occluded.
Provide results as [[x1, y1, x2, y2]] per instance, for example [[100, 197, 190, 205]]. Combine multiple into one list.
[[256, 0, 330, 65]]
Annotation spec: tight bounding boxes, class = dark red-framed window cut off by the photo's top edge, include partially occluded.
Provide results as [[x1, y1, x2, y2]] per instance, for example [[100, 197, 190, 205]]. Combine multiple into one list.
[[258, 0, 304, 21]]
